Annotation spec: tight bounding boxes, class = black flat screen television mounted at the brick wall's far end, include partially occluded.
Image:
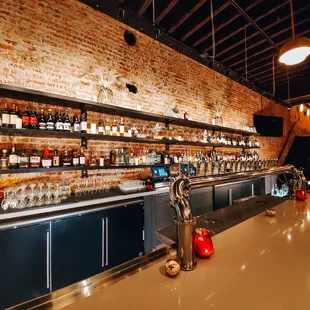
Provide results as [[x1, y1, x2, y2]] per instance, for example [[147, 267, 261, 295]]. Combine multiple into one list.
[[254, 115, 283, 137]]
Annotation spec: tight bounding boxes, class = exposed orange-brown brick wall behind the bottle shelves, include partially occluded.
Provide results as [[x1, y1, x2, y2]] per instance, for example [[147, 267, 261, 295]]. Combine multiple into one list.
[[0, 0, 309, 190]]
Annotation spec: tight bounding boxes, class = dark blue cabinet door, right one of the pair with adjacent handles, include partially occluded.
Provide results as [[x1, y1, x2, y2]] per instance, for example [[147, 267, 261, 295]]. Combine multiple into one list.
[[104, 203, 144, 269]]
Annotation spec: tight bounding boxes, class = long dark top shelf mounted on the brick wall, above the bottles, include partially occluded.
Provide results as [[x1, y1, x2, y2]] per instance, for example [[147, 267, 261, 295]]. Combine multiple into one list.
[[0, 84, 258, 136]]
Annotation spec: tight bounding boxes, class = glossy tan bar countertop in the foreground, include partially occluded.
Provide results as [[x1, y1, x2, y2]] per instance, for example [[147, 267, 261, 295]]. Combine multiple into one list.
[[54, 200, 310, 310]]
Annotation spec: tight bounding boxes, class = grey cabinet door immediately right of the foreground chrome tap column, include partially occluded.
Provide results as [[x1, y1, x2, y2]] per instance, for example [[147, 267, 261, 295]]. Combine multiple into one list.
[[190, 187, 213, 216]]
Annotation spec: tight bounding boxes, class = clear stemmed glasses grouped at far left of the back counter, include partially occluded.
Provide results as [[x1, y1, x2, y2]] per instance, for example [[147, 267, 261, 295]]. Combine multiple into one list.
[[1, 182, 71, 211]]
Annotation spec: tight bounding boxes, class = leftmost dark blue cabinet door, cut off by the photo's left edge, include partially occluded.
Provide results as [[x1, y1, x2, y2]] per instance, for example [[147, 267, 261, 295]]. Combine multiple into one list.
[[0, 223, 50, 309]]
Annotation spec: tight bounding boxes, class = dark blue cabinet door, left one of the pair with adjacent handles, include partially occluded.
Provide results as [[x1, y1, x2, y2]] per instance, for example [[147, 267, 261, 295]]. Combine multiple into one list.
[[52, 213, 103, 290]]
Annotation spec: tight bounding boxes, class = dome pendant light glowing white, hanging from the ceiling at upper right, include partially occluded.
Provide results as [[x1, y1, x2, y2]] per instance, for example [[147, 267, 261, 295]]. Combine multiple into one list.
[[279, 0, 310, 66]]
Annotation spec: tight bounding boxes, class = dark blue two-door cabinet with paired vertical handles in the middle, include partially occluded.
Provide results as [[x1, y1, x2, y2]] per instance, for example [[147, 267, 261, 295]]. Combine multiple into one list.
[[52, 203, 144, 290]]
